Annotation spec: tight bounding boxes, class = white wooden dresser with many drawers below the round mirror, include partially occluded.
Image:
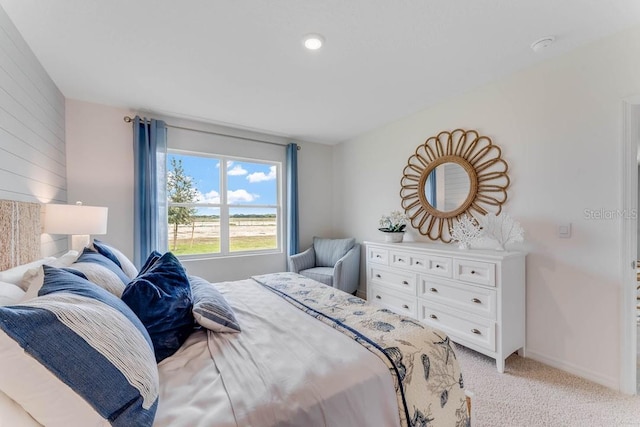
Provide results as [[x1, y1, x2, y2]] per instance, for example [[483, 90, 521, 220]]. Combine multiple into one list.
[[364, 242, 526, 372]]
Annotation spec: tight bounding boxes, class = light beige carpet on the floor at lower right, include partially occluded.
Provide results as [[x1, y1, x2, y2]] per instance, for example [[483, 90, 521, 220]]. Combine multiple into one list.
[[456, 346, 640, 427]]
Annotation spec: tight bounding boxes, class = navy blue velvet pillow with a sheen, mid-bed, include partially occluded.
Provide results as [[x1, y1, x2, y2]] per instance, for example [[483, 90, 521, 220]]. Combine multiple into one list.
[[122, 252, 194, 362]]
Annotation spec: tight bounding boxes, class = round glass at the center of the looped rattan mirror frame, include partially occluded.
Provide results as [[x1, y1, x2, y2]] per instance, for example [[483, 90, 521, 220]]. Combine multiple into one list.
[[424, 162, 471, 212]]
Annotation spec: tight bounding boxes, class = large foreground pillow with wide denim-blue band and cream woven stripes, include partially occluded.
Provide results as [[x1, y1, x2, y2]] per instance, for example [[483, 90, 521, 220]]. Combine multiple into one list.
[[0, 266, 159, 426]]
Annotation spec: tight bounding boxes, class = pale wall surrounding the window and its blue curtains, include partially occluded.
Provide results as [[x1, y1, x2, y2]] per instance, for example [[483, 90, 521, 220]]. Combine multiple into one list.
[[67, 100, 332, 281]]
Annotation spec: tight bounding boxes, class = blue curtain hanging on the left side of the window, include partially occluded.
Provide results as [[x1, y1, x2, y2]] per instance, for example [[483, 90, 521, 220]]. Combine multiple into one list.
[[133, 116, 167, 268]]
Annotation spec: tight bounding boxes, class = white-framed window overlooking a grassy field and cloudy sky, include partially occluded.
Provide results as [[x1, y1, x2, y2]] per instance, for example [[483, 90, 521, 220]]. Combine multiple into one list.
[[167, 150, 281, 256]]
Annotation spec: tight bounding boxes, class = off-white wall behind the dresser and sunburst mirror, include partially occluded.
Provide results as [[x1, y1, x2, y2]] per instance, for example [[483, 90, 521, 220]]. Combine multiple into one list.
[[334, 27, 640, 388]]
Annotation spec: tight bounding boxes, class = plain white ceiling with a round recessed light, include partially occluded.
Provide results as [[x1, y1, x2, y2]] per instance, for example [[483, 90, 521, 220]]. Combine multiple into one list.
[[0, 0, 640, 144]]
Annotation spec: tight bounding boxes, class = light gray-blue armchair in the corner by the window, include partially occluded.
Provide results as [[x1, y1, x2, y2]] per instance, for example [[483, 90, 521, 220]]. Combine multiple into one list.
[[289, 237, 360, 294]]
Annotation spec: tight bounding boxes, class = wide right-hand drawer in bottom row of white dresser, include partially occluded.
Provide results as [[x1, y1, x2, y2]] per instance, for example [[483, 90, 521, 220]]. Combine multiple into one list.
[[418, 300, 496, 351]]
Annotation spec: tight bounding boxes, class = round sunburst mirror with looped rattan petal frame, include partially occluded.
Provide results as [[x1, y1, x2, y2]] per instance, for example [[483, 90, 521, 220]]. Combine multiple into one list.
[[400, 129, 510, 243]]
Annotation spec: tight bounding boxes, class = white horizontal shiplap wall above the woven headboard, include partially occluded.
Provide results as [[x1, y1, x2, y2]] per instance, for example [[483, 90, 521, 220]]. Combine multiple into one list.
[[0, 7, 67, 256]]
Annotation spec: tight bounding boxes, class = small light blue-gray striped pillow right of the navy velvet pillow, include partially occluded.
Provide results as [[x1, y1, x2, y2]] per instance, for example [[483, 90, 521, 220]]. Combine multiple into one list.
[[189, 276, 240, 332]]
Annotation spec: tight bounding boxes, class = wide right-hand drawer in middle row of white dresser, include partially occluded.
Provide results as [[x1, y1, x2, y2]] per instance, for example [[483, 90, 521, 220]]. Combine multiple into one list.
[[418, 275, 497, 320]]
